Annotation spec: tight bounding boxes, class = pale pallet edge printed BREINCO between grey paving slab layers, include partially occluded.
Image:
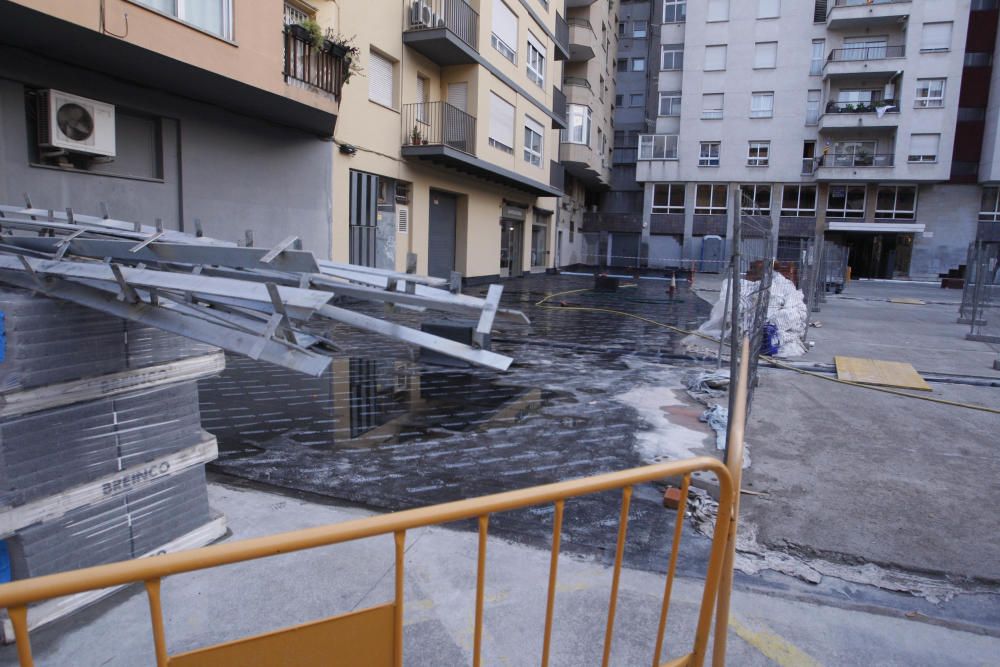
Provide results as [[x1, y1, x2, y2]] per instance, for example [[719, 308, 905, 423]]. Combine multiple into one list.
[[0, 431, 219, 536]]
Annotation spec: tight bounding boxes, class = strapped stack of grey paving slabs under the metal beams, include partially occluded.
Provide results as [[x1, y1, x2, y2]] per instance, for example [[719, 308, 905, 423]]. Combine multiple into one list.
[[0, 289, 225, 641]]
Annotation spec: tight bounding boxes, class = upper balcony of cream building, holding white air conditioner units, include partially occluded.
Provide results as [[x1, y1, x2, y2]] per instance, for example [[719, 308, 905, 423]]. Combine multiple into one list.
[[403, 0, 479, 66]]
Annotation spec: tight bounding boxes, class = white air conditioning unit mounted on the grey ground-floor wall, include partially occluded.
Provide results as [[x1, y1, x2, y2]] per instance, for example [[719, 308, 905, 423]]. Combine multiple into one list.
[[38, 90, 115, 157]]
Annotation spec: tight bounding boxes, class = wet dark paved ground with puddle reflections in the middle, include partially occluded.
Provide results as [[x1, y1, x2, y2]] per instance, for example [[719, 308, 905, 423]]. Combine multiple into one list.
[[201, 276, 713, 571]]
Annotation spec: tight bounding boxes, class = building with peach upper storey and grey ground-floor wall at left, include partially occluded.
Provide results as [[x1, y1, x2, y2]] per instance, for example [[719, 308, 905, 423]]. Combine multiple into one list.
[[0, 0, 344, 256]]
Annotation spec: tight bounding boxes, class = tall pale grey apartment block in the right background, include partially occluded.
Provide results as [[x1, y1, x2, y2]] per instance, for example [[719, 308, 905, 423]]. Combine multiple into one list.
[[609, 0, 997, 278]]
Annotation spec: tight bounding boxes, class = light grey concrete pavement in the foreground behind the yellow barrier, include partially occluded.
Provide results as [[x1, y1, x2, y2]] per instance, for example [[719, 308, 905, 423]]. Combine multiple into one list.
[[0, 484, 1000, 667]]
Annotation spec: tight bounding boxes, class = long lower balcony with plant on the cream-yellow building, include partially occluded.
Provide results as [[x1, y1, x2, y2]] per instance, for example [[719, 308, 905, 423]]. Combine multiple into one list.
[[400, 102, 563, 197]]
